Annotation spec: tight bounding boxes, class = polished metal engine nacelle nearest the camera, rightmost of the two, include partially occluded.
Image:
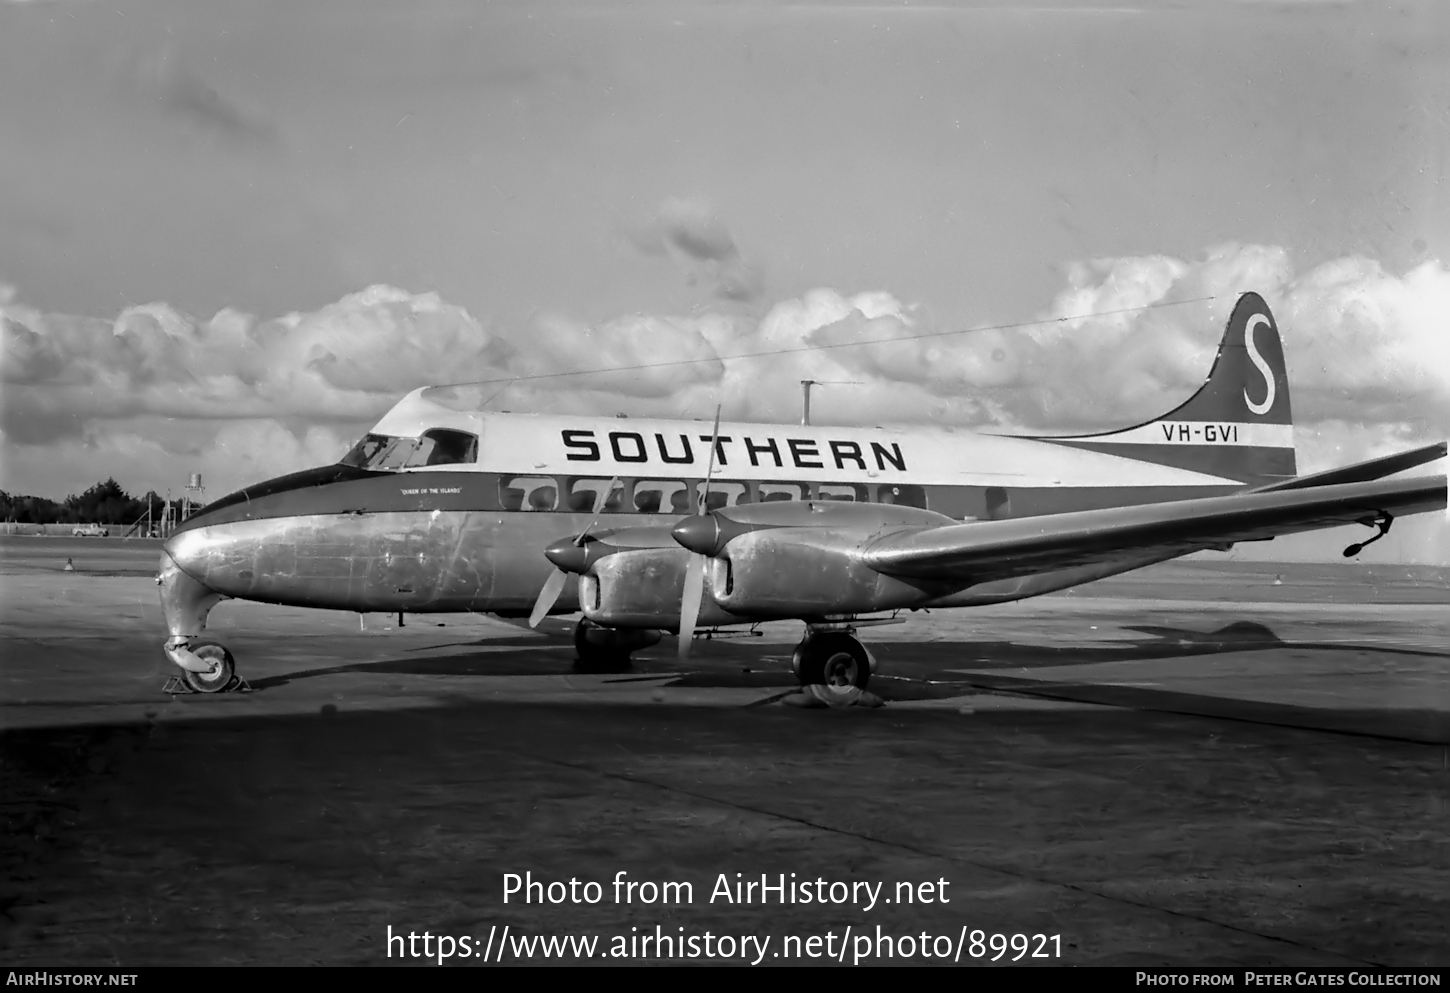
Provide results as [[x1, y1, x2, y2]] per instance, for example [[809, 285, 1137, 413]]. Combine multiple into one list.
[[705, 528, 956, 618]]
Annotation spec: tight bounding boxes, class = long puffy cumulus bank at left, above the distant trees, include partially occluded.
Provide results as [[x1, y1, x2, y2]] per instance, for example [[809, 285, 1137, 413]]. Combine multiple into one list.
[[0, 286, 510, 442]]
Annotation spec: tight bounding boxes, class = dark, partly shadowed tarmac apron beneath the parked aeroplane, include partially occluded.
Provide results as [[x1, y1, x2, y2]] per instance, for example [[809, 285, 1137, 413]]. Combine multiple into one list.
[[0, 538, 1450, 965]]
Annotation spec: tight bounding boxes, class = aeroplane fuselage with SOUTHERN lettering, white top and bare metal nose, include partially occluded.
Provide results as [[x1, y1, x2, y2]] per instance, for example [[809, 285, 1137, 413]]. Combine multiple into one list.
[[167, 387, 1243, 615]]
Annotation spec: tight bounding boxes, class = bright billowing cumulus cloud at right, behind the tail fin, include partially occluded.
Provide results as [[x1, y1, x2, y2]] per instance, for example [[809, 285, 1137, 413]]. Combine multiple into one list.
[[777, 245, 1450, 436]]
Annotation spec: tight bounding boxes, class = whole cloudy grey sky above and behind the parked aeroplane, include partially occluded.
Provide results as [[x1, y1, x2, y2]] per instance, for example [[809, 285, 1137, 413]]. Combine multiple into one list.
[[0, 0, 1450, 562]]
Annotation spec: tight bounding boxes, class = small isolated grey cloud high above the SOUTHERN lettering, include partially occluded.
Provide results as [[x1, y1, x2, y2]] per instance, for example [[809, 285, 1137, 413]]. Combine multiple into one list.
[[628, 197, 764, 300]]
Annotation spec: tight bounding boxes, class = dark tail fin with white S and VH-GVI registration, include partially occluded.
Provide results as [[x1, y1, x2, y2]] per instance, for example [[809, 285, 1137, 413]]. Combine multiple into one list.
[[1044, 293, 1296, 486]]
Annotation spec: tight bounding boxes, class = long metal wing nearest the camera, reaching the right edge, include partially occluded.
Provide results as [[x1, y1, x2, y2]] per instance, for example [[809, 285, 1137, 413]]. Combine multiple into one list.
[[863, 475, 1446, 583]]
